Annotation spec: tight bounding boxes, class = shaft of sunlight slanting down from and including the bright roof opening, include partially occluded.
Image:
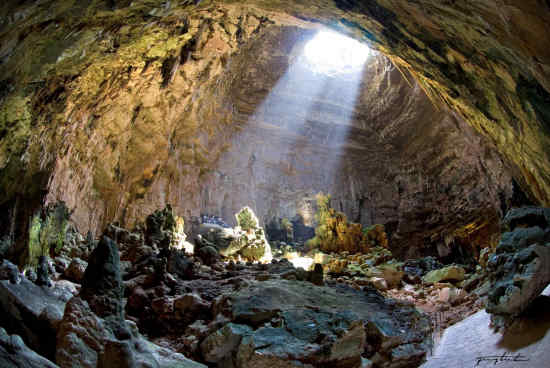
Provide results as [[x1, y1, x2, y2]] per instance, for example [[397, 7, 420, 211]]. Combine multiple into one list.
[[235, 31, 372, 224]]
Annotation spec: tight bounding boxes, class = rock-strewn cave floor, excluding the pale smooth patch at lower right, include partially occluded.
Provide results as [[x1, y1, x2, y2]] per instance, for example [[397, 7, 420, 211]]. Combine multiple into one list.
[[0, 207, 550, 367]]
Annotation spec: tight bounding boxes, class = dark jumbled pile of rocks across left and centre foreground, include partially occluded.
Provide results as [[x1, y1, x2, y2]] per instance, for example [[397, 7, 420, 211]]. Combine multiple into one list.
[[0, 204, 444, 368]]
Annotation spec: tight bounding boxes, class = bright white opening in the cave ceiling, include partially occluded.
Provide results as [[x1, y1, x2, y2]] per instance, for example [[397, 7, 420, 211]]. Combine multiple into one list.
[[304, 31, 371, 74]]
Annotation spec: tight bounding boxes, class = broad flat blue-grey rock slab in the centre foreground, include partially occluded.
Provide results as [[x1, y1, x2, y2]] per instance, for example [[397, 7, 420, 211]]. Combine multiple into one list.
[[220, 280, 429, 367]]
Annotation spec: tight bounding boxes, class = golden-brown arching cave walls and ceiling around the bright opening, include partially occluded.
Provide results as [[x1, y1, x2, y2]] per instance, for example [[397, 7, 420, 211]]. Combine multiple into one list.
[[0, 0, 532, 260]]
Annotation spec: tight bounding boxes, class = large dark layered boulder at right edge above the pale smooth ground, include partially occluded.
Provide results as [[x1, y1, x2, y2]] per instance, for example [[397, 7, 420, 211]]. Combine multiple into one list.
[[487, 207, 550, 328]]
